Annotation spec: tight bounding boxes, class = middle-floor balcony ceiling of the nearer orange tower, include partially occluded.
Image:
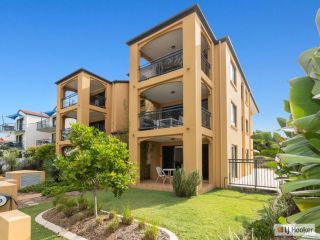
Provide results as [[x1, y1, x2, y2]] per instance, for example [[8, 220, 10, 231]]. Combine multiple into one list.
[[141, 82, 208, 104]]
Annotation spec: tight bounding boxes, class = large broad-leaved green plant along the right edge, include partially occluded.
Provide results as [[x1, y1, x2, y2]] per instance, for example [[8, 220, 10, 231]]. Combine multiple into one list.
[[277, 10, 320, 229]]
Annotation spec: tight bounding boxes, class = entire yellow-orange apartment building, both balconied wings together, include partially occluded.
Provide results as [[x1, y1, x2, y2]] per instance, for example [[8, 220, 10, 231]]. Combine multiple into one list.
[[56, 5, 259, 192]]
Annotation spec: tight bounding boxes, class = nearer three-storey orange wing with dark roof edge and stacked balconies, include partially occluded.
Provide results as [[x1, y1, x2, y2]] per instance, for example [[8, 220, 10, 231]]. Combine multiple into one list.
[[127, 5, 258, 191]]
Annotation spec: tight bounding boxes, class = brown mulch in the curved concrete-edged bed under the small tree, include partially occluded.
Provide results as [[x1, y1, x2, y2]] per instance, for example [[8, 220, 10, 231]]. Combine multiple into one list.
[[43, 208, 169, 240]]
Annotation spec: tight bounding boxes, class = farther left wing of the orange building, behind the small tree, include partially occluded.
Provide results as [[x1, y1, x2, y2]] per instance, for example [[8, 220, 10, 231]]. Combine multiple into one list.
[[56, 69, 128, 154]]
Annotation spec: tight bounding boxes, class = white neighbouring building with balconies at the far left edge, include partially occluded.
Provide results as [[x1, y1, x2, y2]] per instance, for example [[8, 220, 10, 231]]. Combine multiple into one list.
[[0, 109, 52, 150]]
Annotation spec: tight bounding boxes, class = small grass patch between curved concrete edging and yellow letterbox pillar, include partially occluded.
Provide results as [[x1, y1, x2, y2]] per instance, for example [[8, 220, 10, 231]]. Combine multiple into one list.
[[19, 203, 61, 240]]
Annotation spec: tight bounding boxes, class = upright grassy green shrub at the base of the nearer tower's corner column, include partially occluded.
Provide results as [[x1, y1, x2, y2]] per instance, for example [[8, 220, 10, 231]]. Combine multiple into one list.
[[172, 168, 201, 198]]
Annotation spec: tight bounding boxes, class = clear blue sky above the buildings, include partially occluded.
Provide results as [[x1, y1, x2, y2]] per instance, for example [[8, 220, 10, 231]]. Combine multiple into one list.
[[0, 0, 320, 130]]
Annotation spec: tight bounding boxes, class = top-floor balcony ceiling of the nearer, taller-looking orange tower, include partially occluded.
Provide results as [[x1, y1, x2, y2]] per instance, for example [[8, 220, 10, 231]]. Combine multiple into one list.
[[141, 29, 182, 61]]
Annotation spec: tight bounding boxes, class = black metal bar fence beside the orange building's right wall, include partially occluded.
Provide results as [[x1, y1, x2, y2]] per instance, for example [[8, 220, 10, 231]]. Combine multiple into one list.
[[228, 159, 279, 189]]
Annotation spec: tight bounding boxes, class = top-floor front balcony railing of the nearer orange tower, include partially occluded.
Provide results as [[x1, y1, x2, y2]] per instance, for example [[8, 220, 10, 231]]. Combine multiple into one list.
[[139, 49, 183, 81]]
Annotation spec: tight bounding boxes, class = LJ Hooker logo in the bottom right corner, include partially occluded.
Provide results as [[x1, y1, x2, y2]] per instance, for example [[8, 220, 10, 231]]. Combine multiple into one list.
[[273, 224, 315, 236]]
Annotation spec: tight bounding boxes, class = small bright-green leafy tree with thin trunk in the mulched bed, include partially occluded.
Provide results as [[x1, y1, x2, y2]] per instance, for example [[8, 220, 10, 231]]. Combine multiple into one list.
[[55, 124, 136, 217]]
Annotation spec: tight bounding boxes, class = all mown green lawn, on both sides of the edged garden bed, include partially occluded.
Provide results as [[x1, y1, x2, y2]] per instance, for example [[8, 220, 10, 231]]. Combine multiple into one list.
[[22, 189, 271, 240]]
